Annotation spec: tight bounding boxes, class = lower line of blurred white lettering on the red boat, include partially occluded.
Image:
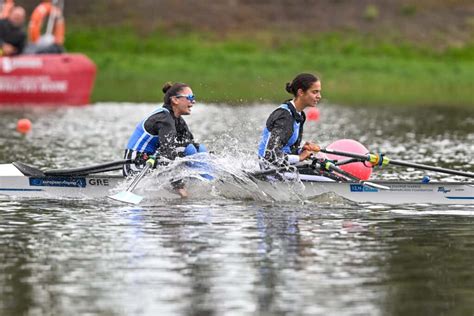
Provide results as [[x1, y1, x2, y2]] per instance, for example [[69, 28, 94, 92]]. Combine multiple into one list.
[[0, 76, 68, 93]]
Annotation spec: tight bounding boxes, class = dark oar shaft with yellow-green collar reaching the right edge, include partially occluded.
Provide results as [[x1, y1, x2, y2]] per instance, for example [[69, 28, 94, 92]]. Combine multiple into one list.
[[321, 148, 474, 178]]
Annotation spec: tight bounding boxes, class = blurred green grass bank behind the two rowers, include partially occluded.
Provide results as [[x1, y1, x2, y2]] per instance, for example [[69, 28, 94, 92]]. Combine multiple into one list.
[[67, 27, 474, 107]]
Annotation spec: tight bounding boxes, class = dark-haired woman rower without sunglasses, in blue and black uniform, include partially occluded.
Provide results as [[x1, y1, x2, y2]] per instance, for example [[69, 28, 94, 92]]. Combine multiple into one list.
[[258, 73, 321, 169]]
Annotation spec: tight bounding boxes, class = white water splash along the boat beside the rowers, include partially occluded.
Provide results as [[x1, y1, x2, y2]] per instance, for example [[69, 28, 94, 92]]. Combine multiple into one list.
[[109, 152, 312, 202]]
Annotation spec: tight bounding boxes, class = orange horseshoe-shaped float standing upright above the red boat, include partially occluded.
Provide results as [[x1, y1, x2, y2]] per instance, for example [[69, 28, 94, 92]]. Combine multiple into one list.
[[28, 2, 66, 45]]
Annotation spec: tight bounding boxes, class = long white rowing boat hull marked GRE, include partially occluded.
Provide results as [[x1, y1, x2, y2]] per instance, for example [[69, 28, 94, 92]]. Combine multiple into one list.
[[0, 164, 474, 205]]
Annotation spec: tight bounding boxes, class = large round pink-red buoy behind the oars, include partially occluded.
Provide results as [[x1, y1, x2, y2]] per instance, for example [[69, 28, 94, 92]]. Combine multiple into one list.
[[326, 139, 372, 180]]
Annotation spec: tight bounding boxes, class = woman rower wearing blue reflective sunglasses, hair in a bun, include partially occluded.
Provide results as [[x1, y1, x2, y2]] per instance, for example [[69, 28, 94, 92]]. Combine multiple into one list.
[[123, 83, 206, 197]]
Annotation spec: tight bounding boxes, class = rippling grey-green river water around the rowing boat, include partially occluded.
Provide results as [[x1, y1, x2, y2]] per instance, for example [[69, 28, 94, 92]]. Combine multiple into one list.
[[0, 104, 474, 315]]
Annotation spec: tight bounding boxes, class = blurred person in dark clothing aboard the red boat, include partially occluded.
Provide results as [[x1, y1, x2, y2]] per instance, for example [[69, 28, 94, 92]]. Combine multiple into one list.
[[0, 6, 26, 56]]
